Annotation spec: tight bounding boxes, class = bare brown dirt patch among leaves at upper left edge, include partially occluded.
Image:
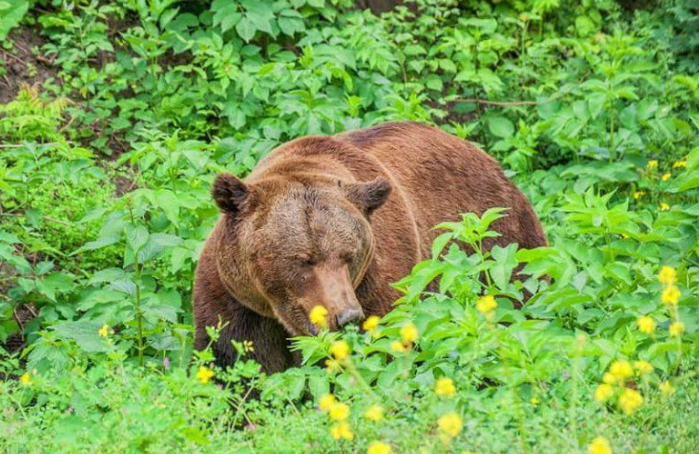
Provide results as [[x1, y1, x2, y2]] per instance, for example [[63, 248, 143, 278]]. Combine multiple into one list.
[[0, 27, 58, 104]]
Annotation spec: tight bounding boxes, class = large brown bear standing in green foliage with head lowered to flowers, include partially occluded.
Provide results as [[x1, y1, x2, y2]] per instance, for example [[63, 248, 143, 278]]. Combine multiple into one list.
[[194, 122, 547, 372]]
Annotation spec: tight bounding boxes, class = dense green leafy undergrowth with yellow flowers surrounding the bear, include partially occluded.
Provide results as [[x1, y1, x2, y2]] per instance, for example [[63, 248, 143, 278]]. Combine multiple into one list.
[[0, 0, 699, 454]]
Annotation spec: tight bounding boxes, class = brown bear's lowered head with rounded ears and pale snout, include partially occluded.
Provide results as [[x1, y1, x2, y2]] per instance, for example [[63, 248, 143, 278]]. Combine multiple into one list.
[[212, 173, 391, 335]]
